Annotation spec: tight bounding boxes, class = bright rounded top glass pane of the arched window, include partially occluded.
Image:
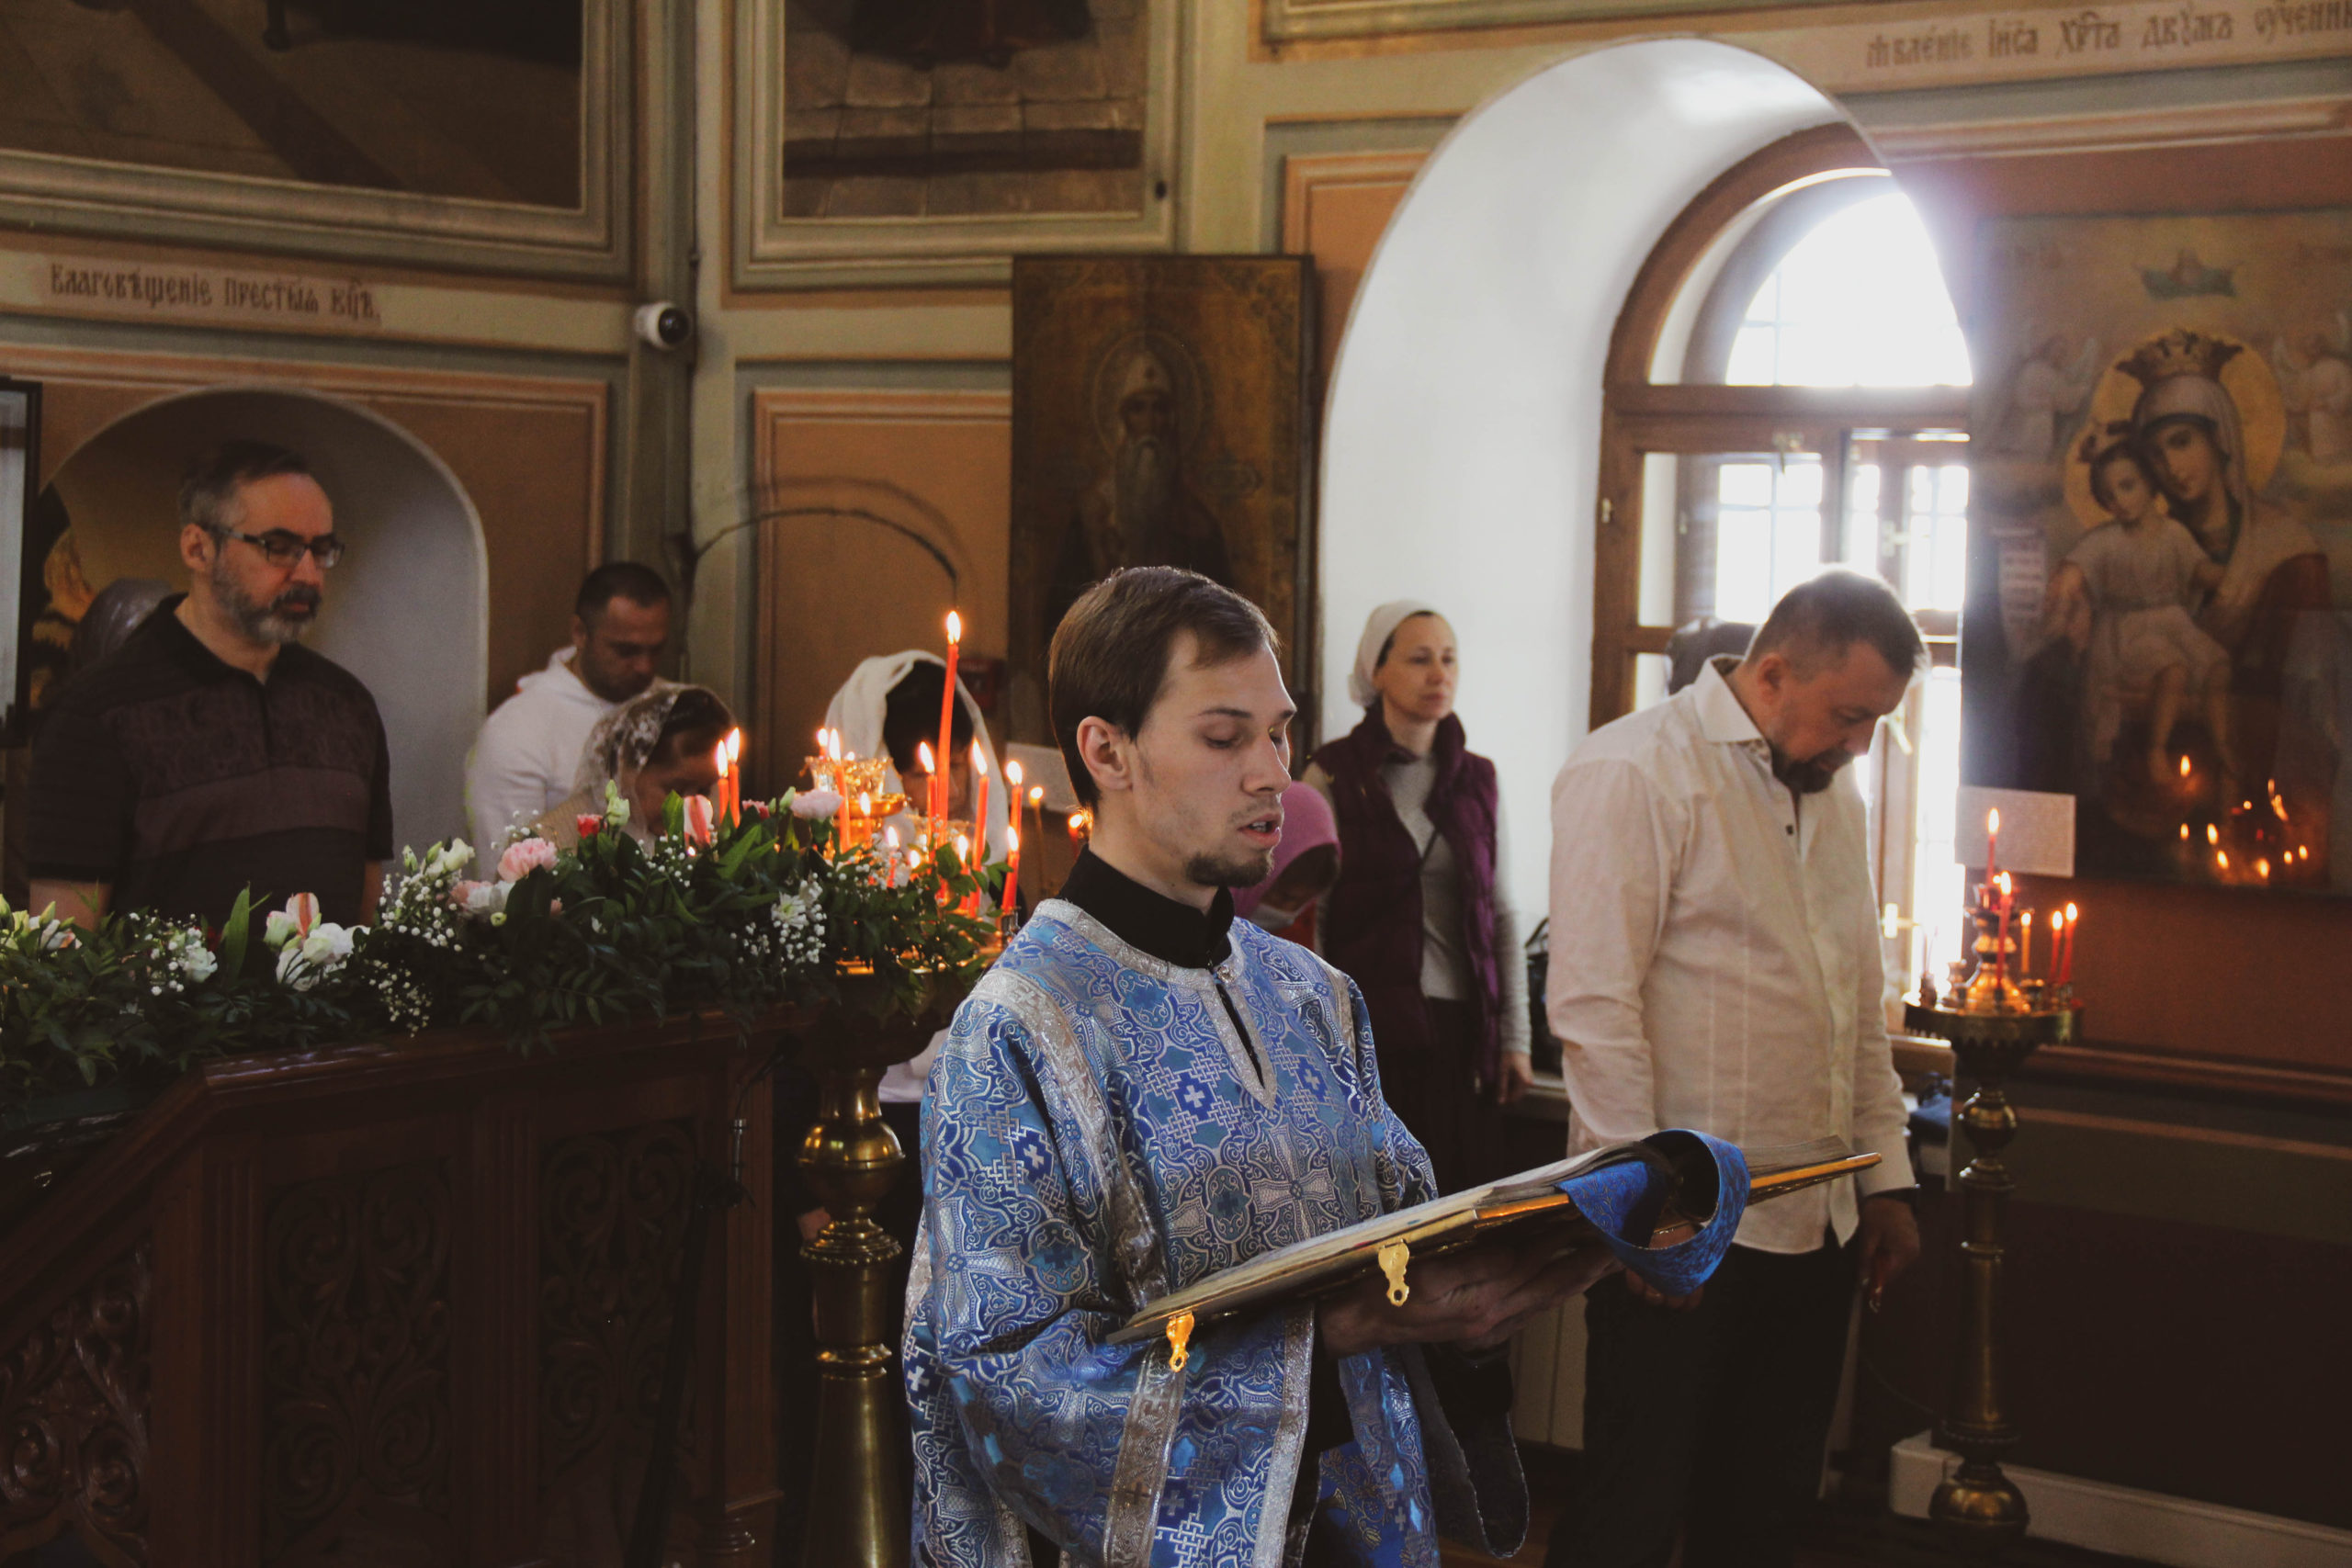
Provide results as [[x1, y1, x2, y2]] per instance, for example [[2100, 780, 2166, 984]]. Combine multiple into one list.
[[1724, 190, 1969, 386]]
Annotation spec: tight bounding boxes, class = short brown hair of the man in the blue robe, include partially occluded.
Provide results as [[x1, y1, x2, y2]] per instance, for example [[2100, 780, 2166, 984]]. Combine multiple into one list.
[[1046, 567, 1282, 807]]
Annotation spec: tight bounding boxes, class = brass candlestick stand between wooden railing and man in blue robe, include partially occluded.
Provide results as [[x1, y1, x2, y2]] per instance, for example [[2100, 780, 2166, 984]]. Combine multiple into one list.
[[799, 971, 945, 1568]]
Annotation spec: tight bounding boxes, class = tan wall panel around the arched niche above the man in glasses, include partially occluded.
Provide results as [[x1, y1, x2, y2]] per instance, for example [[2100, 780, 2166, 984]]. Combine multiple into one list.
[[0, 348, 609, 703]]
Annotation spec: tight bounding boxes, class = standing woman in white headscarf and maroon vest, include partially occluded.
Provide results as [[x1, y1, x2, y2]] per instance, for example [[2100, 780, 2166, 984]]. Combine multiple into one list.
[[1306, 600, 1533, 1192]]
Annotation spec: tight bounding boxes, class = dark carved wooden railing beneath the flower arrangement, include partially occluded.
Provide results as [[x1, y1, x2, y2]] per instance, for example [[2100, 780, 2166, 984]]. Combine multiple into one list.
[[0, 1018, 790, 1568]]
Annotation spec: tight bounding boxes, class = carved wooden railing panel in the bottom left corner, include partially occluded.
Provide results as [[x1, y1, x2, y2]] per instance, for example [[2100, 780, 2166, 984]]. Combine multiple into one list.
[[0, 1241, 153, 1563]]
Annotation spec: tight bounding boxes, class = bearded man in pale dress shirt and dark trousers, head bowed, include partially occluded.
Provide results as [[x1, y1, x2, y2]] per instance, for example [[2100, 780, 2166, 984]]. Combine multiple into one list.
[[1545, 571, 1924, 1568]]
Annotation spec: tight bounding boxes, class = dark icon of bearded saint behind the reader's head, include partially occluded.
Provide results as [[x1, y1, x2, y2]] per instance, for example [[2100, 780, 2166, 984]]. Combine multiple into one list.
[[1009, 256, 1315, 740]]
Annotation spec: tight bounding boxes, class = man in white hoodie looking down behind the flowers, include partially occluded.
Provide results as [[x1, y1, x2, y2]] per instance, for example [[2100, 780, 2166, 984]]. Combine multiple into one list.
[[466, 562, 671, 851]]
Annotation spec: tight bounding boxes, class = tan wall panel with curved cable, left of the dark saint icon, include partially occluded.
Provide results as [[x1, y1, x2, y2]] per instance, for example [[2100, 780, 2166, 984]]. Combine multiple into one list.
[[751, 390, 1012, 792]]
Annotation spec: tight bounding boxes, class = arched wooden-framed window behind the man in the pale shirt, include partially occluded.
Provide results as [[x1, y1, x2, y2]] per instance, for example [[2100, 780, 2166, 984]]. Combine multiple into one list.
[[1592, 125, 1969, 982]]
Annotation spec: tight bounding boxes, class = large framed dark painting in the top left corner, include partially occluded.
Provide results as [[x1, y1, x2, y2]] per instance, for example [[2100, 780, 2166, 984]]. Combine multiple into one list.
[[0, 0, 635, 275]]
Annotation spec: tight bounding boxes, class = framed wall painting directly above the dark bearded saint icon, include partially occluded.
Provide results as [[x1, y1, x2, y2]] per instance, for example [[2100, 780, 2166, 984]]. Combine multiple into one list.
[[734, 0, 1181, 289]]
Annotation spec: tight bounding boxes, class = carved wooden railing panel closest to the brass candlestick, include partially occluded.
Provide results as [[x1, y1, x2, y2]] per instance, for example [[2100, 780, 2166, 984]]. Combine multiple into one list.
[[538, 1122, 694, 1563]]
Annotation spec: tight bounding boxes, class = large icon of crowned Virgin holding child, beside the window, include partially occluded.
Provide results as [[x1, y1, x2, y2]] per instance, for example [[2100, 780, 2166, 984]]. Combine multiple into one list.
[[1962, 211, 2352, 894]]
